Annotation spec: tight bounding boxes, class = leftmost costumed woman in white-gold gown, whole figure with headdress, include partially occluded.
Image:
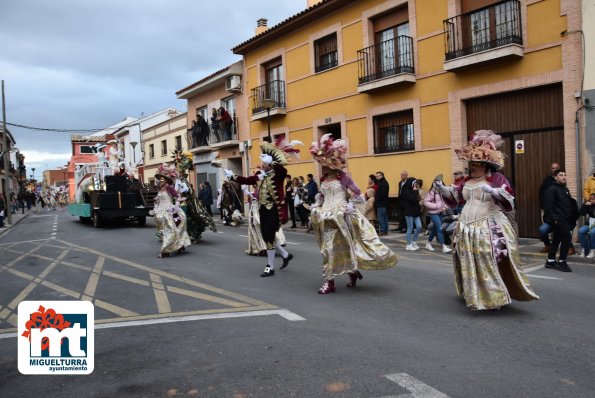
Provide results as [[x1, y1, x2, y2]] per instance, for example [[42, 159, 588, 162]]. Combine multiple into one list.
[[152, 163, 190, 258]]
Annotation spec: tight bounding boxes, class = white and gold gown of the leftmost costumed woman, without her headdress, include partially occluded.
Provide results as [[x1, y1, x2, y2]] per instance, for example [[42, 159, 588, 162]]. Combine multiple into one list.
[[153, 189, 190, 253]]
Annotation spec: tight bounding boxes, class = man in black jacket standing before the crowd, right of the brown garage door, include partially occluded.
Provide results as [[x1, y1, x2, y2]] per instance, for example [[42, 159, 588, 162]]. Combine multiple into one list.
[[542, 169, 578, 272]]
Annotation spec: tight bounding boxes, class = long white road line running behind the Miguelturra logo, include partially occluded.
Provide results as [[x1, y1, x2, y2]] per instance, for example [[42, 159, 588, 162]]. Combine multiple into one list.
[[0, 309, 306, 340]]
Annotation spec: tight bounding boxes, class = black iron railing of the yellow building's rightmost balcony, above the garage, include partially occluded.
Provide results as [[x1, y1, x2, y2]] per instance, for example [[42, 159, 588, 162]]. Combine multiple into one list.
[[444, 0, 523, 61]]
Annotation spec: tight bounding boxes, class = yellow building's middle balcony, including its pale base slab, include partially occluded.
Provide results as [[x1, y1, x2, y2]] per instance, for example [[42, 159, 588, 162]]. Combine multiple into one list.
[[357, 36, 416, 93]]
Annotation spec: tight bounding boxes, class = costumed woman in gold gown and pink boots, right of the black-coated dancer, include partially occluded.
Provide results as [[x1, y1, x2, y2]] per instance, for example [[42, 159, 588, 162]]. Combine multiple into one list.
[[310, 134, 397, 294]]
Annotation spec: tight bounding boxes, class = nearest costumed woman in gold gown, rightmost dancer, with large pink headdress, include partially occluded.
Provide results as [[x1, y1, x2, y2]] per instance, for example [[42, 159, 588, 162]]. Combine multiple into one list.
[[436, 130, 539, 310]]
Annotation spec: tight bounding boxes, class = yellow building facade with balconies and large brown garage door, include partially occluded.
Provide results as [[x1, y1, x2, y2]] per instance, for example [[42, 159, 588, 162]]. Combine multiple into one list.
[[233, 0, 583, 236]]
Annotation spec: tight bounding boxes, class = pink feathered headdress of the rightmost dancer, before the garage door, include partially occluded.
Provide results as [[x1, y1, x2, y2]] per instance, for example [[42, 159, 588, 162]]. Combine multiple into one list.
[[455, 130, 504, 170]]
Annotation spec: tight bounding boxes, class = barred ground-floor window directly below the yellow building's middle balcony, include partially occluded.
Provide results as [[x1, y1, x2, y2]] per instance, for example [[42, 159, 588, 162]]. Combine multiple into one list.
[[374, 110, 415, 153]]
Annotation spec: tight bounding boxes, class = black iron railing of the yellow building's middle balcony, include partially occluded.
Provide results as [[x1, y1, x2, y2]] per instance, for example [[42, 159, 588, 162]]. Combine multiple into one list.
[[357, 36, 415, 84]]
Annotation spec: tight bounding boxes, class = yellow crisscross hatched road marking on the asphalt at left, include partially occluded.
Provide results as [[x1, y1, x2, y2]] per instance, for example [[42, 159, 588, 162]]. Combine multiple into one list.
[[0, 239, 288, 336]]
